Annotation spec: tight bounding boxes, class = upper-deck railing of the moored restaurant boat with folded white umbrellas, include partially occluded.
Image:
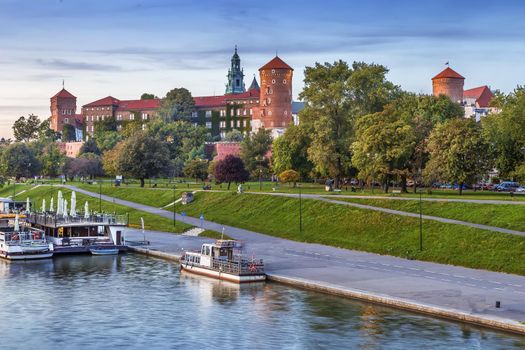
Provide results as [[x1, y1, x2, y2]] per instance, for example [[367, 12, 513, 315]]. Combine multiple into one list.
[[29, 213, 128, 227]]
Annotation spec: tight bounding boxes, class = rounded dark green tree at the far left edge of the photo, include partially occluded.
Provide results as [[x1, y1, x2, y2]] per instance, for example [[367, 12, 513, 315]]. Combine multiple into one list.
[[0, 143, 40, 180]]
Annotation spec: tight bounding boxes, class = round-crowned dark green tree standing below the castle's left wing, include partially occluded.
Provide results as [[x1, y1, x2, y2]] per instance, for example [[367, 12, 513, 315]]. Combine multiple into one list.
[[116, 132, 170, 187]]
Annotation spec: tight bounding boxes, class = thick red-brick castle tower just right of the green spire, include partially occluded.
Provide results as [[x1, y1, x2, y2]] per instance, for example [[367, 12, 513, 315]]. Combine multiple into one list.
[[253, 56, 293, 136]]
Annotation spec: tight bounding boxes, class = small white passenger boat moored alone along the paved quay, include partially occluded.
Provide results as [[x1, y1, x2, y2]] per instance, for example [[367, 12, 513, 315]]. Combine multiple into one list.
[[180, 239, 266, 283]]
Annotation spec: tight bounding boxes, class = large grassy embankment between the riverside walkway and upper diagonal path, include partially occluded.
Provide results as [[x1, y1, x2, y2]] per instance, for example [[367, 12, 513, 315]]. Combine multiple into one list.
[[177, 192, 525, 275]]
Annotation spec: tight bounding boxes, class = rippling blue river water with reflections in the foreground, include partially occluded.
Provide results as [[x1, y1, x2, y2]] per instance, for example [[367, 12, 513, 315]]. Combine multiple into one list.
[[0, 254, 525, 350]]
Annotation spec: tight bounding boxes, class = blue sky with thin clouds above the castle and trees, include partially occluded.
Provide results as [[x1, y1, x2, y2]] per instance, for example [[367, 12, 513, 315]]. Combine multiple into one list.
[[0, 0, 525, 137]]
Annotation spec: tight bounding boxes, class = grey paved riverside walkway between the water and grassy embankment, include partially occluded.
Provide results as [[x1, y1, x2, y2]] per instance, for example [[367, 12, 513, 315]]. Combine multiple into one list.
[[66, 186, 525, 334]]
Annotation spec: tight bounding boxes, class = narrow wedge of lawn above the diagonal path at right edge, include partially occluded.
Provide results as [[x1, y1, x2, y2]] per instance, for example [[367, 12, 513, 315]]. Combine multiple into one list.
[[332, 198, 525, 231]]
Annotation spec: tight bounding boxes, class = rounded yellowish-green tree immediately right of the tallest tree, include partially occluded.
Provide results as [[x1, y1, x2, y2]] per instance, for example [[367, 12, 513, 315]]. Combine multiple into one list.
[[351, 108, 416, 193]]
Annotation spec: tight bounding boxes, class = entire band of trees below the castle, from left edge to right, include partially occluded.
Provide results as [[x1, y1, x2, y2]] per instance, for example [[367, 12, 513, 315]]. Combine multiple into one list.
[[0, 61, 525, 191]]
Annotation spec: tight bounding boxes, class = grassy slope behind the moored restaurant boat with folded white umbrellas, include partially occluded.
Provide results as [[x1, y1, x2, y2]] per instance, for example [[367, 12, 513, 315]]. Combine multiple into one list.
[[16, 186, 191, 232]]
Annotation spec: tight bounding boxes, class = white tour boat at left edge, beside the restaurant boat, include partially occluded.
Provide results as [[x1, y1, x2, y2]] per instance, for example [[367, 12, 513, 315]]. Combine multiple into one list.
[[0, 227, 53, 260]]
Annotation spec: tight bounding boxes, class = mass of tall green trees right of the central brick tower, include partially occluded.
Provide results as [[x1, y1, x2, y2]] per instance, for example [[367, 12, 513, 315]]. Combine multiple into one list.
[[272, 61, 525, 191]]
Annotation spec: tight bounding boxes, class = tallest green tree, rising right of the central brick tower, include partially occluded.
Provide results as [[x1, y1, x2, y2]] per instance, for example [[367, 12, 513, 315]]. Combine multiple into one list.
[[299, 60, 399, 187]]
